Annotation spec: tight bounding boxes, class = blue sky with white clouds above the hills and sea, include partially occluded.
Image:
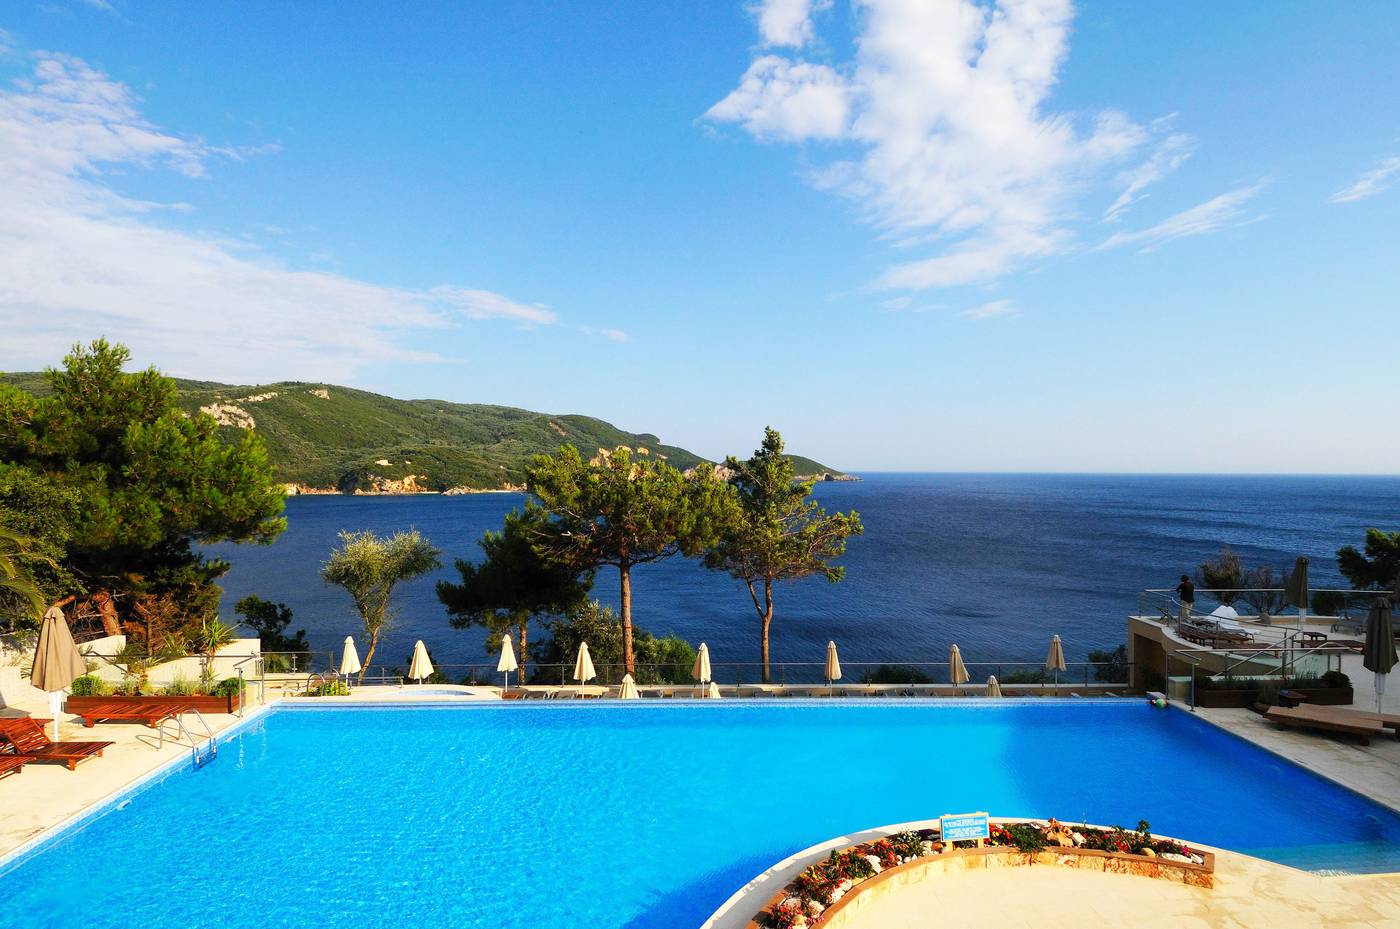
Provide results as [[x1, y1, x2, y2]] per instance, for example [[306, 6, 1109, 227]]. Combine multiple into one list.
[[0, 0, 1400, 473]]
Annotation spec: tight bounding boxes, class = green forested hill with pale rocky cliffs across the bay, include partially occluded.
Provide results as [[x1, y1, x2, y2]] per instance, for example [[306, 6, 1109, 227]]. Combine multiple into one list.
[[0, 372, 844, 492]]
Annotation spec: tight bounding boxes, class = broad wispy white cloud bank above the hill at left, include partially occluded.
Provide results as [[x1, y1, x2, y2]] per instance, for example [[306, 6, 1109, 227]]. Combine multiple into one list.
[[0, 53, 568, 382]]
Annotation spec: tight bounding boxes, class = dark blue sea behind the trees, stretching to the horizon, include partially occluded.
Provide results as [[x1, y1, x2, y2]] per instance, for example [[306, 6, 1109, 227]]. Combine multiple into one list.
[[207, 473, 1400, 680]]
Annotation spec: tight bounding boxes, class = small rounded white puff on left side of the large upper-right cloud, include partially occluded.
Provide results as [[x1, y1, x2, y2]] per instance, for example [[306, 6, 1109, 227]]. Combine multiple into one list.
[[706, 55, 851, 141]]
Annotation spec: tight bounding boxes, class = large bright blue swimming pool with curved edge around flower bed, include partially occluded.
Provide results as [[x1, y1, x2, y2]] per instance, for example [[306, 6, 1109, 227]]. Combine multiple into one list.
[[0, 700, 1400, 929]]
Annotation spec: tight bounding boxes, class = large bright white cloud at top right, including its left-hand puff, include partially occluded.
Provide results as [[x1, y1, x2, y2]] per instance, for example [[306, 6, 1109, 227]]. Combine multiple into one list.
[[706, 0, 1189, 288]]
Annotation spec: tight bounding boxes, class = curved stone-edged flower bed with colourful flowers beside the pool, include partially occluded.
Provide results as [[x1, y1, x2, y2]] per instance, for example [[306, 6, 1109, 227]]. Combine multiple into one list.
[[748, 820, 1215, 929]]
